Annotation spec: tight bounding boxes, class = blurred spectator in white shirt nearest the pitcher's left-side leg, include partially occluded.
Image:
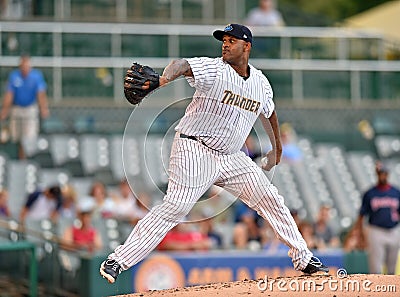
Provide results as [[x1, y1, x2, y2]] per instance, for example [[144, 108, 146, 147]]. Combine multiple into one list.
[[113, 179, 151, 224]]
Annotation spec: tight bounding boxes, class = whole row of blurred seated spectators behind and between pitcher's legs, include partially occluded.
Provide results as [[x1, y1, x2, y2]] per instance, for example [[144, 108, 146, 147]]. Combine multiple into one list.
[[0, 180, 364, 253]]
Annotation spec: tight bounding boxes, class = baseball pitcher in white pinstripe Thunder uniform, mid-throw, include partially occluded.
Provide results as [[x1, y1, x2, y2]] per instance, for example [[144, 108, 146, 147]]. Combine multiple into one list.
[[100, 24, 328, 283]]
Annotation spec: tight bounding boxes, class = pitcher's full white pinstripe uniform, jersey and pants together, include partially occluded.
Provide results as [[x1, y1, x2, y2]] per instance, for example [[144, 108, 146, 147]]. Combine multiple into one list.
[[109, 58, 312, 270]]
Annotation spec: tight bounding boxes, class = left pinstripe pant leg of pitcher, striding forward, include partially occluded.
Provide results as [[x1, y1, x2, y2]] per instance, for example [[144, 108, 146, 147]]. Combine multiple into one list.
[[109, 134, 220, 269]]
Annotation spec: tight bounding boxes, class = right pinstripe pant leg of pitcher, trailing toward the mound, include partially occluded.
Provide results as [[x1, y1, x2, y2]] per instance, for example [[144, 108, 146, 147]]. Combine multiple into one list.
[[217, 152, 312, 270]]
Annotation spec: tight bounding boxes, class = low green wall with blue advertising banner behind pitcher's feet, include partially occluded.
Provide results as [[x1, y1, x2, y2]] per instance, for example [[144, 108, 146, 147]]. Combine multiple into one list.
[[80, 250, 376, 297]]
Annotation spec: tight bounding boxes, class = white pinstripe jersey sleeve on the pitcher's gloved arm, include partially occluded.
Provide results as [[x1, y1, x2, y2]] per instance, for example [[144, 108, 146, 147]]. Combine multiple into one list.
[[186, 57, 219, 92]]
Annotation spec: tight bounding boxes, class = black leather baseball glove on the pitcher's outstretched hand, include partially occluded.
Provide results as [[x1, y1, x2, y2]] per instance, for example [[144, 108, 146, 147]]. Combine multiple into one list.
[[124, 63, 160, 105]]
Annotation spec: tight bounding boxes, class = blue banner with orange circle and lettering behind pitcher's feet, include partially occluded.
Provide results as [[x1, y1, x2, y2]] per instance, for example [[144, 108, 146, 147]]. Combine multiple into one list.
[[131, 251, 344, 292]]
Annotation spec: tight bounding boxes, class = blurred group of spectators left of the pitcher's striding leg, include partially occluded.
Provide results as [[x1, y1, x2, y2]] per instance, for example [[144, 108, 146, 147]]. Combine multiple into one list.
[[0, 179, 151, 252]]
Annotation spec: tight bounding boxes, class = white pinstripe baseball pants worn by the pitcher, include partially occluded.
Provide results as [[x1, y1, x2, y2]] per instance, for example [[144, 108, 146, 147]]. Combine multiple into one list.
[[109, 134, 312, 270]]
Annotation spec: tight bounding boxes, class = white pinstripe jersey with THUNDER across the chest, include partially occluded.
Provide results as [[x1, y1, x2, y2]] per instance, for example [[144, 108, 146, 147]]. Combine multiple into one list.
[[176, 57, 275, 154]]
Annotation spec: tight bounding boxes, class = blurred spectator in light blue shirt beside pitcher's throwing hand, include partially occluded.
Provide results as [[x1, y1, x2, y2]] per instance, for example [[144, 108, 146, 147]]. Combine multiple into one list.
[[280, 123, 303, 163]]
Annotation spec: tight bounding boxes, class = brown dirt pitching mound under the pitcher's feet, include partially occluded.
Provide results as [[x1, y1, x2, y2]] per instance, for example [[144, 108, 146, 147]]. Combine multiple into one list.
[[114, 274, 400, 297]]
